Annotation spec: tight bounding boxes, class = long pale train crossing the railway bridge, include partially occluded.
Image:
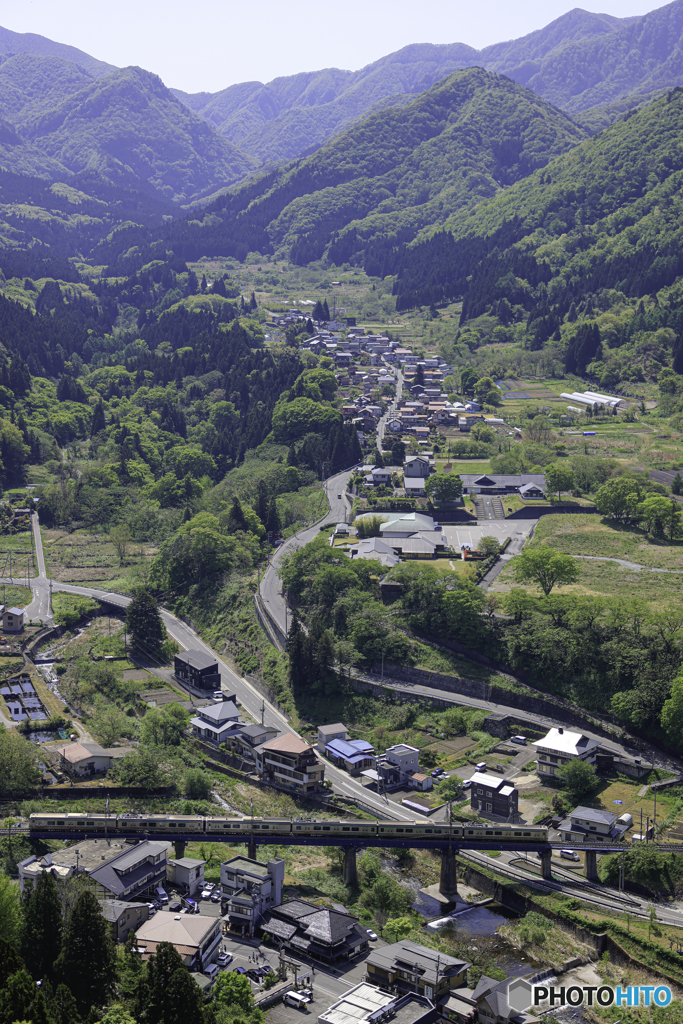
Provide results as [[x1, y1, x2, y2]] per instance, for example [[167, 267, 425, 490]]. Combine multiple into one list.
[[29, 814, 548, 845]]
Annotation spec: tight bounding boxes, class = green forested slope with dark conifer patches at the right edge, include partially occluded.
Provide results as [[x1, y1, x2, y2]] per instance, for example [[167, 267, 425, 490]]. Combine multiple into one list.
[[392, 89, 683, 386]]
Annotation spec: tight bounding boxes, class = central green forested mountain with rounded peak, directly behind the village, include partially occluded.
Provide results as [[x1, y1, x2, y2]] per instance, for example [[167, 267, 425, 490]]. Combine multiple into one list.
[[120, 69, 585, 273]]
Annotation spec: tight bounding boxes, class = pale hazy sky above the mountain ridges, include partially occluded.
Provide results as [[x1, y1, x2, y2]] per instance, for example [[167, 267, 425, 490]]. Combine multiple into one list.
[[0, 0, 663, 92]]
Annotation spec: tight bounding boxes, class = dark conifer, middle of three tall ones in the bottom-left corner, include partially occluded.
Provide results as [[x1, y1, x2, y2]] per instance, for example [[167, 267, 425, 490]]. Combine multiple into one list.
[[55, 889, 116, 1016]]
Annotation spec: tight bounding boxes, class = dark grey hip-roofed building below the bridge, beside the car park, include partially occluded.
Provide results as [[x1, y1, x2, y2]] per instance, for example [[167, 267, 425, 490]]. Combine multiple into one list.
[[261, 899, 368, 964]]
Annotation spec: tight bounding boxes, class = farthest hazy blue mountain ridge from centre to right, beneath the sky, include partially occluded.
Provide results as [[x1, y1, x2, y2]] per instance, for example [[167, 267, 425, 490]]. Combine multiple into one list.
[[176, 0, 683, 156]]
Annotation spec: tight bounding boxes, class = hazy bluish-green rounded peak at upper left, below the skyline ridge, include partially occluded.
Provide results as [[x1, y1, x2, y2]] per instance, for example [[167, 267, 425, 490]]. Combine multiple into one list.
[[23, 68, 253, 203]]
